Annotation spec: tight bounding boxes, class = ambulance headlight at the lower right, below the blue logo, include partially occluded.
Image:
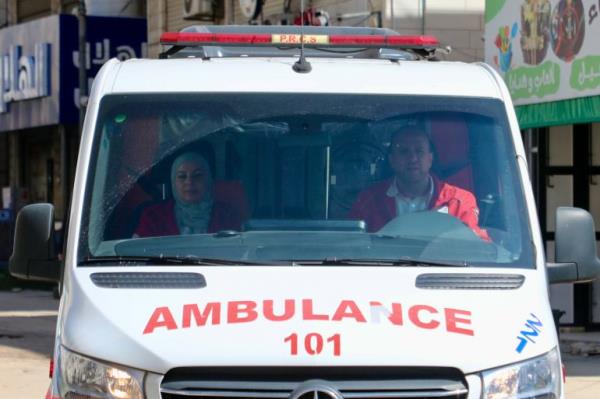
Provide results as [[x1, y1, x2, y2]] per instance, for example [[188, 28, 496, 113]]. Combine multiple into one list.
[[482, 348, 561, 399]]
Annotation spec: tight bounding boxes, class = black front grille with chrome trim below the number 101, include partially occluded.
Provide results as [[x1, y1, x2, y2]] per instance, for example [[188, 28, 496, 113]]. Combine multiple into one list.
[[161, 367, 468, 399]]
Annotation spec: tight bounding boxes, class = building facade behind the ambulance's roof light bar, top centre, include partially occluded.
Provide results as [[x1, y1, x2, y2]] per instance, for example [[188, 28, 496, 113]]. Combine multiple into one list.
[[147, 0, 485, 62]]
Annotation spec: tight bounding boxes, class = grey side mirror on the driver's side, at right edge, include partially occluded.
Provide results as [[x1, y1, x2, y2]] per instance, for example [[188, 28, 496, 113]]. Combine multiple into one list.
[[547, 207, 600, 284]]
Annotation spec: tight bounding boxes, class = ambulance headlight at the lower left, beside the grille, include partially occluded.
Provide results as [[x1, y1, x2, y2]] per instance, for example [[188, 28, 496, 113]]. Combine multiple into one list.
[[58, 347, 144, 399]]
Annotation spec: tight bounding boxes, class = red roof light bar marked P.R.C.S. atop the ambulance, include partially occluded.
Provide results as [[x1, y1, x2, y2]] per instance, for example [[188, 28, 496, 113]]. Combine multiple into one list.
[[160, 32, 440, 49]]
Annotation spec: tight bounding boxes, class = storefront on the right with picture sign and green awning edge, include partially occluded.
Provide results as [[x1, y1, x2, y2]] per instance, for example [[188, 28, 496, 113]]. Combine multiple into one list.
[[485, 0, 600, 329]]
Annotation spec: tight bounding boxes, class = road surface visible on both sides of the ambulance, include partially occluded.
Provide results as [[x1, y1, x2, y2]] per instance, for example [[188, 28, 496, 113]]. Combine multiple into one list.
[[0, 291, 600, 399]]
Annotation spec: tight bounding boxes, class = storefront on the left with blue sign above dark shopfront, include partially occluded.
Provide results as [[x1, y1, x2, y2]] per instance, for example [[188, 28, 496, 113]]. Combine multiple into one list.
[[0, 15, 147, 257]]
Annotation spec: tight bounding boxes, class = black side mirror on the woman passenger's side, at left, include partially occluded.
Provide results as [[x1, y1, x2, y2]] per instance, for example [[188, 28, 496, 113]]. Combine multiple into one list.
[[8, 204, 60, 281]]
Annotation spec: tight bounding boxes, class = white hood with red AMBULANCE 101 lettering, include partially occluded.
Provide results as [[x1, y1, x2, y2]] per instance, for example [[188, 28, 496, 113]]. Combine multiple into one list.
[[59, 266, 557, 373]]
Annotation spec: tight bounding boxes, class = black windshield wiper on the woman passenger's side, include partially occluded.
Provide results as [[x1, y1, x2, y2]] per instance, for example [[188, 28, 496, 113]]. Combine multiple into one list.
[[81, 255, 263, 266]]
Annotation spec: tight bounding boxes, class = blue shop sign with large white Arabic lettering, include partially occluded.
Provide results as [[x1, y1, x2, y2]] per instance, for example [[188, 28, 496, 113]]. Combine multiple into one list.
[[0, 15, 147, 132]]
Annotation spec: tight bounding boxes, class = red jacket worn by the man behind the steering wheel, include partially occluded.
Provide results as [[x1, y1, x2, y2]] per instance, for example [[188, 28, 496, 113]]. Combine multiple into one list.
[[348, 176, 490, 241]]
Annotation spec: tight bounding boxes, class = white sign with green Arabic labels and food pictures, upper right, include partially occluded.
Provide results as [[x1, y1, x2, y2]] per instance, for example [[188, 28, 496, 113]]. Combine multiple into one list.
[[485, 0, 600, 105]]
